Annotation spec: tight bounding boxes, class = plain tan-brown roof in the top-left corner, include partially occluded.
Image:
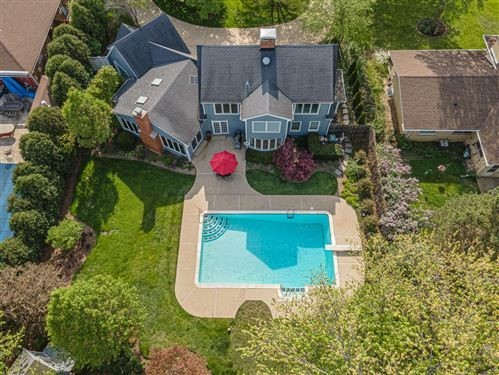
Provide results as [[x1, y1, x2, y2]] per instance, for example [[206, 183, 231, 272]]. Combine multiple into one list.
[[0, 0, 60, 73]]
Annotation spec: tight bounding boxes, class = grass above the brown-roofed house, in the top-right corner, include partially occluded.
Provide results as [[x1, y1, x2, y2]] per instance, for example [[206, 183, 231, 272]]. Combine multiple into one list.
[[374, 0, 499, 49]]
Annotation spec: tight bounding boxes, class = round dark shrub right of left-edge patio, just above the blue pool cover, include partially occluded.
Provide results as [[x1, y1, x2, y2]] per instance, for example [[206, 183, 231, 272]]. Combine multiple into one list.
[[19, 132, 61, 168]]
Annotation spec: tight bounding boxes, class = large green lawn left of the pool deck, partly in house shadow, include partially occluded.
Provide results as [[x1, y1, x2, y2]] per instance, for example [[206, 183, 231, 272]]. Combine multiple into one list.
[[71, 159, 232, 373]]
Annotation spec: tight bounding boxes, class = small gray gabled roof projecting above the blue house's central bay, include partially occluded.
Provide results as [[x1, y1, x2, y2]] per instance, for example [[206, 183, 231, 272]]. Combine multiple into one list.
[[241, 81, 293, 120]]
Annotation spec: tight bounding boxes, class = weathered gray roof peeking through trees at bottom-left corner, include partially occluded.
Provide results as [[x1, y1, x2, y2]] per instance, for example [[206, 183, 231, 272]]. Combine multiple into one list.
[[8, 346, 74, 375]]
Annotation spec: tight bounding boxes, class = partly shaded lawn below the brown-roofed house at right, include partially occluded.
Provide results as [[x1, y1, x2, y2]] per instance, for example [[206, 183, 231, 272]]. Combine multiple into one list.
[[402, 143, 478, 209]]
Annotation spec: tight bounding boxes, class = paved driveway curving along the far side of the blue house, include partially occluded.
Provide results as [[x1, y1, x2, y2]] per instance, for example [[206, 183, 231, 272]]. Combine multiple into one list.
[[139, 1, 321, 56]]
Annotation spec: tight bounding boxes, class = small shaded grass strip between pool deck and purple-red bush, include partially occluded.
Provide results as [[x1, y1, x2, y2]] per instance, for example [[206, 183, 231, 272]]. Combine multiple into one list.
[[246, 169, 338, 195]]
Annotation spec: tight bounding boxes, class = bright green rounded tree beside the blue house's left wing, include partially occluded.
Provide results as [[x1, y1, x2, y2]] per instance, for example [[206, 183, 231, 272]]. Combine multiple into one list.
[[62, 89, 111, 148]]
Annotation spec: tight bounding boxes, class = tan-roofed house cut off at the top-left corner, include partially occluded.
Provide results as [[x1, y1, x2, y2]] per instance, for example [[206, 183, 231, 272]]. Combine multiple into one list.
[[0, 0, 68, 90]]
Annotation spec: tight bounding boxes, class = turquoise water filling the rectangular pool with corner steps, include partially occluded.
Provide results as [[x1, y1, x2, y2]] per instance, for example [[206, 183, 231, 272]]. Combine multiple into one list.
[[198, 213, 335, 288]]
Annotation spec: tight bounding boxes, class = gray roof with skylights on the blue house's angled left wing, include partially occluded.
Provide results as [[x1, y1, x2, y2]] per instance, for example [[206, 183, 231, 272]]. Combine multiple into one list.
[[113, 60, 199, 144]]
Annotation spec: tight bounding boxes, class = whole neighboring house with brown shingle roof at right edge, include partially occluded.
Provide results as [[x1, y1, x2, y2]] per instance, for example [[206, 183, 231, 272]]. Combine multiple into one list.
[[389, 35, 499, 177]]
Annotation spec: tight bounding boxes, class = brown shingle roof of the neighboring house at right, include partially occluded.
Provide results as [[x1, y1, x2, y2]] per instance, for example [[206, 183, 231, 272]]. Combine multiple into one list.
[[390, 50, 499, 164]]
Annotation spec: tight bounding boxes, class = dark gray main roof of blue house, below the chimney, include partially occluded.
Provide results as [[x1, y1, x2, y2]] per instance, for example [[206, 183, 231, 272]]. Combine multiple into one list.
[[197, 44, 337, 103]]
